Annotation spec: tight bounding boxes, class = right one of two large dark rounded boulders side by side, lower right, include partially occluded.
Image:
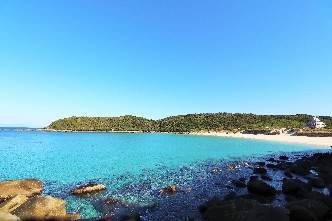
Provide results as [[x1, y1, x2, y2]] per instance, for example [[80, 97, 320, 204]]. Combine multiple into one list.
[[282, 178, 312, 195]]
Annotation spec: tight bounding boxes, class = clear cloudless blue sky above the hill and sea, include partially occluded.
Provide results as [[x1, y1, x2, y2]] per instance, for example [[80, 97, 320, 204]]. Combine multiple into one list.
[[0, 0, 332, 126]]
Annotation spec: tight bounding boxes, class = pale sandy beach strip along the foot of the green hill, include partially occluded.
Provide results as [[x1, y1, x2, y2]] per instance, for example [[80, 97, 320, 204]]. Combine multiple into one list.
[[192, 132, 332, 148]]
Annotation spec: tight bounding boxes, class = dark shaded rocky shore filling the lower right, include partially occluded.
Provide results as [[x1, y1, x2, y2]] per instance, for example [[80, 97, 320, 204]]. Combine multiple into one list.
[[200, 153, 332, 221]]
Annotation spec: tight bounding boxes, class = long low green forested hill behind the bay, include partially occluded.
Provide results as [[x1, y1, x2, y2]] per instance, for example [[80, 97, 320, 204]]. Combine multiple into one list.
[[45, 113, 332, 132]]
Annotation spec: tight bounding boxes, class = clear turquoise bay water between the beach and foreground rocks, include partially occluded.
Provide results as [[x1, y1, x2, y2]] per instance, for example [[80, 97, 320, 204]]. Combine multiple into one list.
[[0, 131, 324, 217]]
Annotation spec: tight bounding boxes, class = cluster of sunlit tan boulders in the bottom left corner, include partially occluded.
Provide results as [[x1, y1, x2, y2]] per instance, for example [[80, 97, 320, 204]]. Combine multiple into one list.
[[0, 179, 80, 221]]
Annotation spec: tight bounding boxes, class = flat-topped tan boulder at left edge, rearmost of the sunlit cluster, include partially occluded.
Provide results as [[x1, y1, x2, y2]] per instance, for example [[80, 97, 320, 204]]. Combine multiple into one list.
[[0, 179, 43, 201]]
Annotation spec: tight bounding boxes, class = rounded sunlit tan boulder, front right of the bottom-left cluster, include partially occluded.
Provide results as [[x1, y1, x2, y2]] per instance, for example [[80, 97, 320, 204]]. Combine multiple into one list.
[[12, 196, 66, 220]]
